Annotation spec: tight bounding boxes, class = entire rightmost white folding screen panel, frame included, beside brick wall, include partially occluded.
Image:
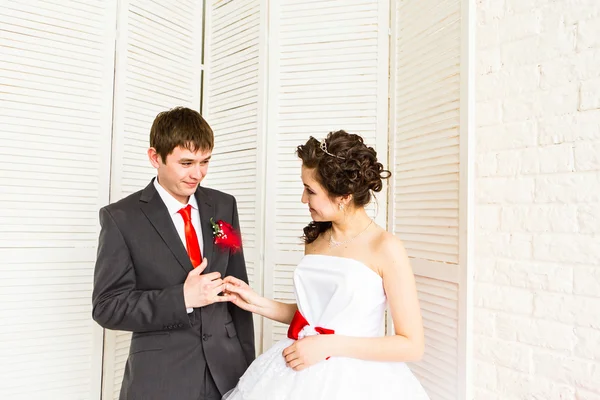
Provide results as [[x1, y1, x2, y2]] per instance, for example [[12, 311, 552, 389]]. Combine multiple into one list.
[[389, 0, 470, 400]]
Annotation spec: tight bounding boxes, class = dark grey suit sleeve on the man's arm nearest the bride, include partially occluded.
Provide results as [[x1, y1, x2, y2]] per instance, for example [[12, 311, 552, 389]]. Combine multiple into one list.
[[227, 198, 256, 365]]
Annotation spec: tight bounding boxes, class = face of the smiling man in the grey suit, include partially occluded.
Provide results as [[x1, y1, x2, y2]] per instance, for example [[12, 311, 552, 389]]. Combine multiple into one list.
[[148, 147, 212, 204]]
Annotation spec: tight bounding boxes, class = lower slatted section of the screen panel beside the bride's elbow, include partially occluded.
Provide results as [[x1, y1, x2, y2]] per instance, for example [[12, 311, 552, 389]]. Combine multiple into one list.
[[411, 276, 458, 400]]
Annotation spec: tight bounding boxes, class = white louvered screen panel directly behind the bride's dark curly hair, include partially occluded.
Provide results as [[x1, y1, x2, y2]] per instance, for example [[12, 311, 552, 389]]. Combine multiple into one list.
[[263, 0, 389, 348]]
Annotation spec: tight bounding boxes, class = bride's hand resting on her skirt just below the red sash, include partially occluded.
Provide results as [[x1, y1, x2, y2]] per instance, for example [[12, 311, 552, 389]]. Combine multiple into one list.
[[283, 335, 334, 371]]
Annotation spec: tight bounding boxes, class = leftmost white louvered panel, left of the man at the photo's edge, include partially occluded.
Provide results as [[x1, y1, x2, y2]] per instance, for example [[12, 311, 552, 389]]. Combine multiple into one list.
[[0, 0, 116, 399]]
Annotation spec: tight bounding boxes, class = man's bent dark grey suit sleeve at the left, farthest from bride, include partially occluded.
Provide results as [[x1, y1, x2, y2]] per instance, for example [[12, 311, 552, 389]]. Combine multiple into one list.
[[92, 207, 191, 332]]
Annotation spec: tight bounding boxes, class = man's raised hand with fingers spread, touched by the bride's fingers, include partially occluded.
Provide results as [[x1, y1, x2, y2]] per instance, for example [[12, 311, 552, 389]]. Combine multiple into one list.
[[183, 258, 231, 308]]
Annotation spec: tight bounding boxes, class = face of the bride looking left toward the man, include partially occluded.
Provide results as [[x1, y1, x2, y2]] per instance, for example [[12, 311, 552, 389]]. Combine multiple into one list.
[[302, 166, 339, 222]]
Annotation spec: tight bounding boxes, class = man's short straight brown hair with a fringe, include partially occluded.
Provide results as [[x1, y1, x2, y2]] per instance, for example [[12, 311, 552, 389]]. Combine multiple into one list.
[[150, 107, 215, 163]]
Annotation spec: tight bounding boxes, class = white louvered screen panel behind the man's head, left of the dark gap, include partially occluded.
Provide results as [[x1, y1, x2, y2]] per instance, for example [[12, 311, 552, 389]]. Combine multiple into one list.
[[103, 0, 202, 399]]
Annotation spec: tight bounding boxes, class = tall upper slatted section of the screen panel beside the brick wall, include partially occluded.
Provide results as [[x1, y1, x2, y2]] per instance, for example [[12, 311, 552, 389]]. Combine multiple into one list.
[[394, 0, 461, 263]]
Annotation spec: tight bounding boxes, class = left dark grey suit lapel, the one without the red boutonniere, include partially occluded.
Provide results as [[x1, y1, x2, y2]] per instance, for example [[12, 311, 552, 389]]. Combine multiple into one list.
[[140, 179, 192, 272]]
